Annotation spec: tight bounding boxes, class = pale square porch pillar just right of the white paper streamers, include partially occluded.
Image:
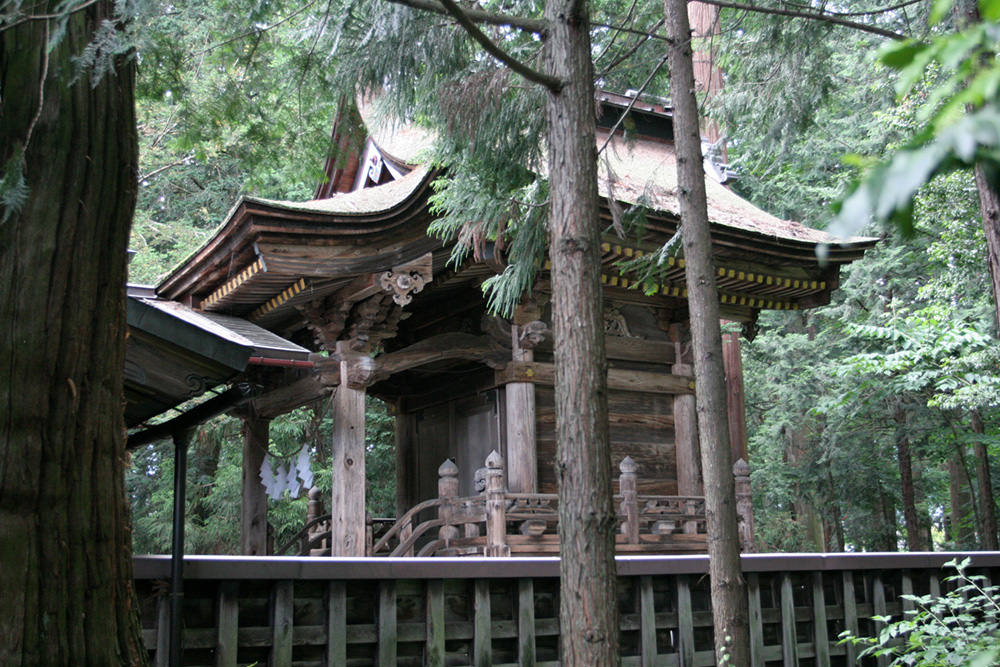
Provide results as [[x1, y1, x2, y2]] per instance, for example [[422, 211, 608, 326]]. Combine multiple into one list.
[[330, 341, 372, 556]]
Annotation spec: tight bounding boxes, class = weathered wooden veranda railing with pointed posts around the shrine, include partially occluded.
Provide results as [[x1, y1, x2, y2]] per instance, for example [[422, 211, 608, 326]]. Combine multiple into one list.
[[276, 451, 753, 557]]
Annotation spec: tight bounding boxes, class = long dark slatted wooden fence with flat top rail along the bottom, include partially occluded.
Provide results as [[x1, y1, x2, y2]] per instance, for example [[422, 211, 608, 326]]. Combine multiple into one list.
[[135, 552, 1000, 667]]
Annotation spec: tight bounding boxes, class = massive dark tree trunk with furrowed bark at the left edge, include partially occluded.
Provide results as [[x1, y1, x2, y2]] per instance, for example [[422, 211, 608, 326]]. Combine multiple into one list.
[[0, 0, 146, 665]]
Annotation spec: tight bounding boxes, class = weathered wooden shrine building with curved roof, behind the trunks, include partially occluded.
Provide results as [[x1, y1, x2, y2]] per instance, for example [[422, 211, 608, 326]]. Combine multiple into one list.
[[141, 93, 874, 556]]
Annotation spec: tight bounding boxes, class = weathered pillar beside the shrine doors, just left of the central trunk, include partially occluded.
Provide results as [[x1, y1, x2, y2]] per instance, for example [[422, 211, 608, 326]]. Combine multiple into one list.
[[505, 322, 545, 493]]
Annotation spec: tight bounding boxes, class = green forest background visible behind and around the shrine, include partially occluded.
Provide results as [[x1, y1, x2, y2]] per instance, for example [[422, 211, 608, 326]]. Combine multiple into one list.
[[127, 0, 1000, 553]]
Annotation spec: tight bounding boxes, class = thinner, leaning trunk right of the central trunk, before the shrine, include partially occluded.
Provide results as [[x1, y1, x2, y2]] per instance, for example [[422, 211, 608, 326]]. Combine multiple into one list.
[[664, 0, 750, 665]]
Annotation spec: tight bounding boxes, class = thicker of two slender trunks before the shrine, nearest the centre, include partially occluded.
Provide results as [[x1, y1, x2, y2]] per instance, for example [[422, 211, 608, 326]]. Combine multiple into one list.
[[544, 0, 619, 666]]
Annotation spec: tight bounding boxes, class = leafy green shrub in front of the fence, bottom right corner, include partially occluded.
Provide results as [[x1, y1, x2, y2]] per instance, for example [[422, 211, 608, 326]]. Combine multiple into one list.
[[840, 558, 1000, 667]]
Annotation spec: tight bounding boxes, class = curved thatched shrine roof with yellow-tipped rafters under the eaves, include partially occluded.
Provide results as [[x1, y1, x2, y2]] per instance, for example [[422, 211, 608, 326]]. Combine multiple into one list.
[[157, 112, 876, 336]]
